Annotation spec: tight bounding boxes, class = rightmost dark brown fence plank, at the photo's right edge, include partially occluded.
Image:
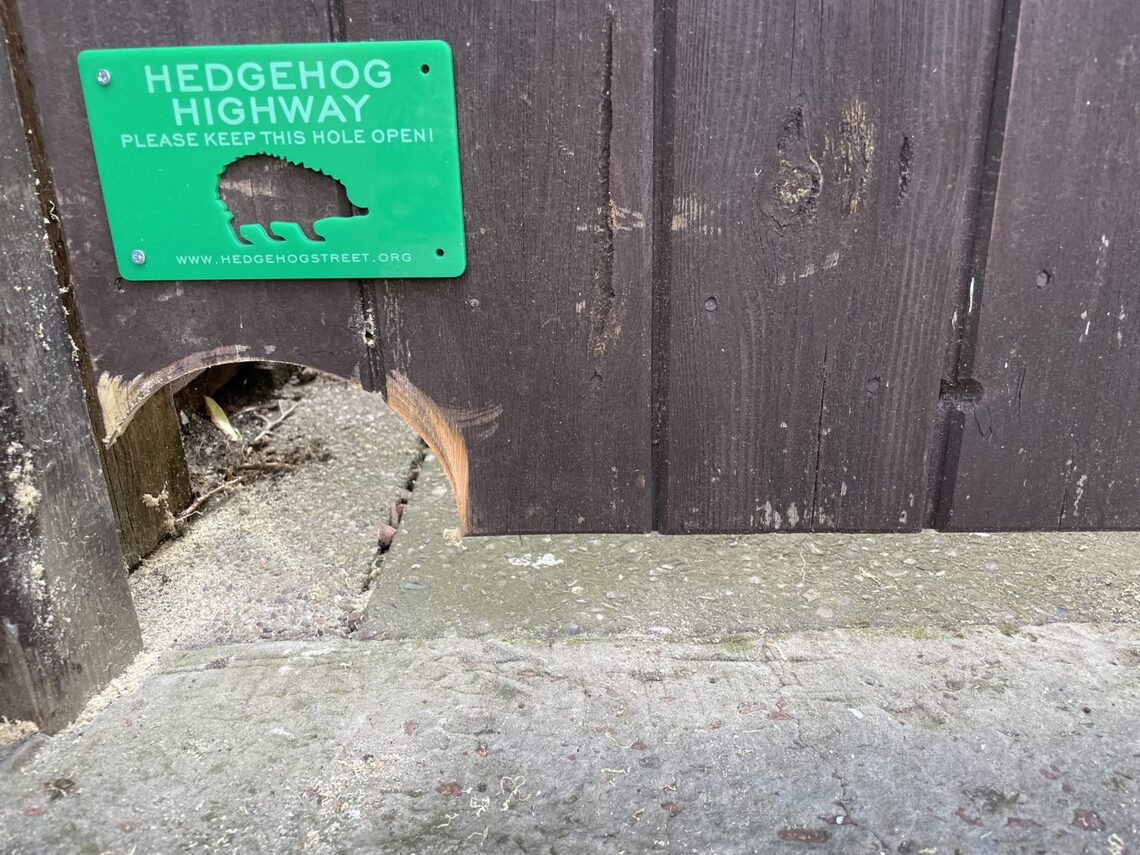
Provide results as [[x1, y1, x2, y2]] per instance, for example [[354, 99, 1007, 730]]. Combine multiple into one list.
[[945, 0, 1140, 529]]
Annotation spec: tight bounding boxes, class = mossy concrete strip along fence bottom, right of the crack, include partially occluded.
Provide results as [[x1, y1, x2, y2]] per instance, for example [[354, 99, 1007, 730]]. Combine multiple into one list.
[[360, 457, 1140, 640]]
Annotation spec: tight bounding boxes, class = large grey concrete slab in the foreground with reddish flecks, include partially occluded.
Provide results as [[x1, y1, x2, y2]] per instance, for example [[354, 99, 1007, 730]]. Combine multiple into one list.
[[0, 624, 1140, 855]]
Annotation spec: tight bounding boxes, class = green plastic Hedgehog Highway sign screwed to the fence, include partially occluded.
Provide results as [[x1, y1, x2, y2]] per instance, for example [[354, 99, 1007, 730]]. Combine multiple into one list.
[[79, 41, 466, 280]]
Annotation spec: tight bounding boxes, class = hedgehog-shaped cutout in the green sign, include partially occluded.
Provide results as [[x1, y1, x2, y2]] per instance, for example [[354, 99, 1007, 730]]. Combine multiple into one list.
[[218, 153, 368, 245]]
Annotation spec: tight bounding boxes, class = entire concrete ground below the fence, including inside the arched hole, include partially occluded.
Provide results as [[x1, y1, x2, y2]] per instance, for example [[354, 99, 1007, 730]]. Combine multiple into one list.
[[0, 389, 1140, 855]]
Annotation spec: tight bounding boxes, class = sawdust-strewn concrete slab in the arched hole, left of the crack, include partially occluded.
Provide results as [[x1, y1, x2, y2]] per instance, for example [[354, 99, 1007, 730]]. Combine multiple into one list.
[[131, 377, 421, 653]]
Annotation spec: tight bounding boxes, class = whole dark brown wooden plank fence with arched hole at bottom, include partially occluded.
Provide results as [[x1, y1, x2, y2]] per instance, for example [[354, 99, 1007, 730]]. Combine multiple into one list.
[[0, 0, 1140, 725]]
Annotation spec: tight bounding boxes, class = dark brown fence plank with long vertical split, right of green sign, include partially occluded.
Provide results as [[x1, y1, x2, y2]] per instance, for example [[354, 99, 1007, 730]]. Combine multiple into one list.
[[344, 0, 653, 534]]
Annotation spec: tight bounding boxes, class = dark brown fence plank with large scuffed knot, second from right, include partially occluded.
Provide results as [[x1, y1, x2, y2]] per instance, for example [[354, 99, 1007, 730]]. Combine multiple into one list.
[[663, 0, 1001, 531]]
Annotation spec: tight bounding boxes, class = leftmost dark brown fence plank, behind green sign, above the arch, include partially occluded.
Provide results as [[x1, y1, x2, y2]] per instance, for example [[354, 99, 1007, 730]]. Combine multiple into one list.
[[18, 0, 376, 438]]
